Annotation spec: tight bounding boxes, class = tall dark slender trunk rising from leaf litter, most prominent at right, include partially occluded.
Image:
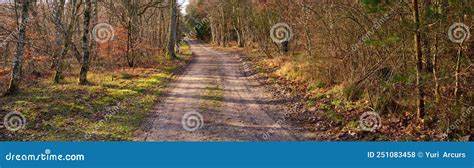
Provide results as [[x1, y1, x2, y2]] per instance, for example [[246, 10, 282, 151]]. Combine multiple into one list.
[[413, 0, 425, 122]]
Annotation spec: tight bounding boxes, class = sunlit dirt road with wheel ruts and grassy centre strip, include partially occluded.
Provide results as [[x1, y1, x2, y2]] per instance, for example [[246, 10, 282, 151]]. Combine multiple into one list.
[[139, 41, 297, 141]]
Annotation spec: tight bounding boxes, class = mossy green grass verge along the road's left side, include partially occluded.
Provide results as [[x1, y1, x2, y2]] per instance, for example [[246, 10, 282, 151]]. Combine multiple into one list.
[[0, 45, 192, 141]]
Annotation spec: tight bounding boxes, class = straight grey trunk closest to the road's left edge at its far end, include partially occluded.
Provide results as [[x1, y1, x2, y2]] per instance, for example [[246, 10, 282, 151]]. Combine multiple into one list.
[[166, 0, 177, 59]]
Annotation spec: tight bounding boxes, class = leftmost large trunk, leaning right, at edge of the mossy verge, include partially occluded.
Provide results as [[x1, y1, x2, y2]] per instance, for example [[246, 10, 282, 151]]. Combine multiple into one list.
[[6, 0, 30, 95]]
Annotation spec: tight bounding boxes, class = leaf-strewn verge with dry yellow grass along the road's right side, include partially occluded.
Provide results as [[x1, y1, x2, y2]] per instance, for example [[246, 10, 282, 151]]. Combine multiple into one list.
[[223, 47, 466, 141]]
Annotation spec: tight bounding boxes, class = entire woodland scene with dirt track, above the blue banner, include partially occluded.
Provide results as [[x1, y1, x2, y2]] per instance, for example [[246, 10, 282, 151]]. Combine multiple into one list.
[[0, 0, 474, 141]]
